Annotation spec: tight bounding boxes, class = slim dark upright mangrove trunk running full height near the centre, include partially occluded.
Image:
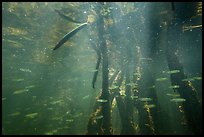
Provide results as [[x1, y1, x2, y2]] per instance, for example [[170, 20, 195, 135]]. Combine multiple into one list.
[[88, 3, 112, 135]]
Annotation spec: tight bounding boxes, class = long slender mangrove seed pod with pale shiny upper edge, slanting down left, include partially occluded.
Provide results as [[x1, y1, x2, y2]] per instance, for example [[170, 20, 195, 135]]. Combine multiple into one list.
[[53, 22, 87, 50]]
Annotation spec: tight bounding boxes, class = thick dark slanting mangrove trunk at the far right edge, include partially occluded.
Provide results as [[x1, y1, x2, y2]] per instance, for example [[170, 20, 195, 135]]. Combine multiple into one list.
[[167, 45, 202, 134]]
